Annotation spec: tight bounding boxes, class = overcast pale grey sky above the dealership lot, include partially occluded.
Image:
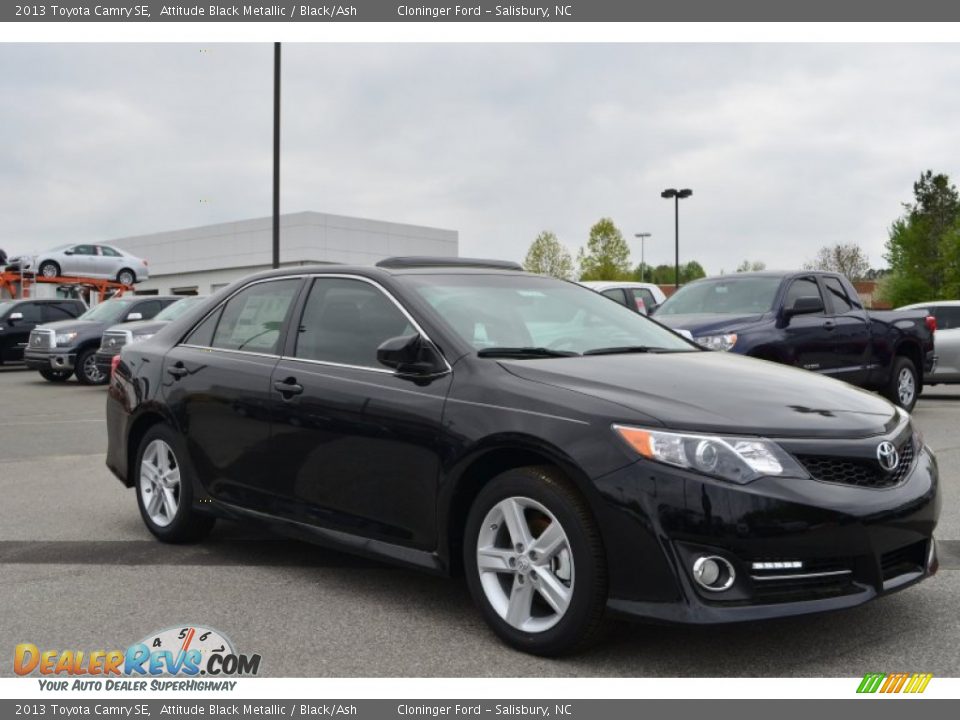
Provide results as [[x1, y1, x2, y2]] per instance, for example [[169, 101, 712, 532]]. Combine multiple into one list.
[[0, 44, 960, 273]]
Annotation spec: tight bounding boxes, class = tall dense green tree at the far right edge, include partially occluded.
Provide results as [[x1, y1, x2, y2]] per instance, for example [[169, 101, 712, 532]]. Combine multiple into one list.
[[879, 170, 960, 307]]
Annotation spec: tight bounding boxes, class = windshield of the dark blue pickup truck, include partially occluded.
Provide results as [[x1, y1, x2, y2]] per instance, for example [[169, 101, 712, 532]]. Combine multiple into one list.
[[657, 276, 781, 317]]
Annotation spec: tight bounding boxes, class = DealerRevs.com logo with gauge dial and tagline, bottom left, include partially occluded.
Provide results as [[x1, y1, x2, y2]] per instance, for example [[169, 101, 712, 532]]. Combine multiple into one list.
[[13, 625, 260, 690]]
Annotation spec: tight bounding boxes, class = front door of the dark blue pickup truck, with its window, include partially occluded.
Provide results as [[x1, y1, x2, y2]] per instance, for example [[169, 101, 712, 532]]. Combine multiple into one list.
[[782, 276, 837, 373]]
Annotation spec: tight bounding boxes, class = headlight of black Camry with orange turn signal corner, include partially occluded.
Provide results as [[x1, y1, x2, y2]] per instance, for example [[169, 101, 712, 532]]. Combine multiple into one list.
[[613, 425, 809, 484]]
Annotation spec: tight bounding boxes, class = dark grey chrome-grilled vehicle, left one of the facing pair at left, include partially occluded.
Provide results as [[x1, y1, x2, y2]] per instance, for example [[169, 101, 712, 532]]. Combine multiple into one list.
[[23, 295, 180, 385]]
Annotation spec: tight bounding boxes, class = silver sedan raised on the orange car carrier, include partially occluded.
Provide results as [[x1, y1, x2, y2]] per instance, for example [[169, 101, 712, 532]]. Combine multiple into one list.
[[7, 244, 150, 285]]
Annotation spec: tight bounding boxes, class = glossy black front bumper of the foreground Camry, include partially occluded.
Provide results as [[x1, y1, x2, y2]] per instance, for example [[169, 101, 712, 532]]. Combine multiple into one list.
[[596, 438, 940, 624]]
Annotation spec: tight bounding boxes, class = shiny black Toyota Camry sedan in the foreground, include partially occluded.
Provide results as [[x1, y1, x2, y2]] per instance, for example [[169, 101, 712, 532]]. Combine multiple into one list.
[[107, 258, 940, 655]]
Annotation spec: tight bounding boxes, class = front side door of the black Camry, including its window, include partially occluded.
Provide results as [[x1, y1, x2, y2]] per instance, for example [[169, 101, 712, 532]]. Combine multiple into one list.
[[264, 276, 451, 550]]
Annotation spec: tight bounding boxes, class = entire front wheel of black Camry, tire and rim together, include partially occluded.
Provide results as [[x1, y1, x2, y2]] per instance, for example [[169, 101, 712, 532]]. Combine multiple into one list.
[[464, 467, 607, 656]]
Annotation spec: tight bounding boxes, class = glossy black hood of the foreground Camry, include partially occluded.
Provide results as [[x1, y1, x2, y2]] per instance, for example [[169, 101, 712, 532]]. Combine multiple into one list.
[[500, 352, 898, 438]]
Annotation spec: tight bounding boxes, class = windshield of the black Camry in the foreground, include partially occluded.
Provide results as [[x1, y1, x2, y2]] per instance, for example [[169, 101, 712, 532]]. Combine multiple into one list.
[[400, 273, 698, 356]]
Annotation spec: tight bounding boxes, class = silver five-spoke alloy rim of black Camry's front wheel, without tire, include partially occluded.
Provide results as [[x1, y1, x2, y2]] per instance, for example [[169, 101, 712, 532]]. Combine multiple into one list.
[[477, 497, 574, 633]]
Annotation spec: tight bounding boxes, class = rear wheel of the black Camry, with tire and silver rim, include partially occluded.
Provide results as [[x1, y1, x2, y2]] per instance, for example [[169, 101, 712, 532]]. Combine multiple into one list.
[[134, 423, 216, 543]]
